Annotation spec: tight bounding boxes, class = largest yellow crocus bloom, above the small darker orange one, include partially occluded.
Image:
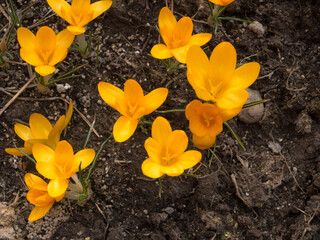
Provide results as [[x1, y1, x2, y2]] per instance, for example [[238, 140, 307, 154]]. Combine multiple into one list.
[[187, 42, 260, 121]]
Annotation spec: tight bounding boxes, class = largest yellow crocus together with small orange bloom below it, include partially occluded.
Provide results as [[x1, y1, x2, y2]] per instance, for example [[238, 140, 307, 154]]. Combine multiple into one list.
[[186, 42, 260, 149]]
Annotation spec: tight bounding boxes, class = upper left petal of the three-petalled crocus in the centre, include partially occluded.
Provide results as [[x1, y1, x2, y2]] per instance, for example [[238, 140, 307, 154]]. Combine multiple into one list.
[[98, 82, 124, 109]]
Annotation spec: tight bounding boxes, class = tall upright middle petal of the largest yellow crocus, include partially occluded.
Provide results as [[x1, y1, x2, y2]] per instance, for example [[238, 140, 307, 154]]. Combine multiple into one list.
[[209, 42, 237, 86]]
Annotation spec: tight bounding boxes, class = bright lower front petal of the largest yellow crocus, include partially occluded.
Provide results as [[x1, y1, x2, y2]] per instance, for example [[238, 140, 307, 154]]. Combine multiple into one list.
[[217, 88, 249, 109]]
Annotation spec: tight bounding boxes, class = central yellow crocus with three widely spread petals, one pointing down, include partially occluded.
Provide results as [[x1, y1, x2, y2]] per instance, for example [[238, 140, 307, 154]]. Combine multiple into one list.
[[98, 79, 168, 142]]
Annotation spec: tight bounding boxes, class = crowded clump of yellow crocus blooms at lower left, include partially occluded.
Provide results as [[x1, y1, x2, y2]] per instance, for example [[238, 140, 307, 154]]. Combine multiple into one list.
[[5, 102, 95, 221]]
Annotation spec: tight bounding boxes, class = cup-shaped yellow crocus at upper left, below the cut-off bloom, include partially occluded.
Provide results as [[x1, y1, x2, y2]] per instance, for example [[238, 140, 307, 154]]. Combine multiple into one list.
[[17, 26, 74, 76]]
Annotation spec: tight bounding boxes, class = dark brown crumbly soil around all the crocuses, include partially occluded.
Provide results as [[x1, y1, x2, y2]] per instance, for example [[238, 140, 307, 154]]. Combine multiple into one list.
[[0, 0, 320, 240]]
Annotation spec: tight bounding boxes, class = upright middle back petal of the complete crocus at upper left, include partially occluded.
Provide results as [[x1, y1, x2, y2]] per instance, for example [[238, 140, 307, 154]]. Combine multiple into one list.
[[35, 26, 56, 53]]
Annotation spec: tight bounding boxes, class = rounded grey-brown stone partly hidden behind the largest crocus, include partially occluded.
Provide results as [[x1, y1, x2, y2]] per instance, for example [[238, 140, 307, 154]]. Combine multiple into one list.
[[238, 88, 264, 123]]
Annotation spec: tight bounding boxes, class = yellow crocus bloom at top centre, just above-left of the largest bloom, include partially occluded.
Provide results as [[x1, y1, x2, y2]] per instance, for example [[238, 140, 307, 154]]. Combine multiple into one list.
[[151, 7, 212, 63]]
